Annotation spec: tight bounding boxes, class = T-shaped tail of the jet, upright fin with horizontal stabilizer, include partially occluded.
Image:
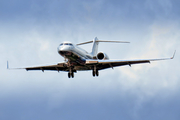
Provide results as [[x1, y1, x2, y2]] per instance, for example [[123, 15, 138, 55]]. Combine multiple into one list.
[[77, 37, 130, 56]]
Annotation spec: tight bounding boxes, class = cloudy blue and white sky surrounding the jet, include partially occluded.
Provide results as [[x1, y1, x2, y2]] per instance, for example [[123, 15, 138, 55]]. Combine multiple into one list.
[[0, 0, 180, 120]]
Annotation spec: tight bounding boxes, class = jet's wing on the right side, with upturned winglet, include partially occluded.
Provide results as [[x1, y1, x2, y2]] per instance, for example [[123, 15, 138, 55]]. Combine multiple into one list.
[[86, 53, 175, 70]]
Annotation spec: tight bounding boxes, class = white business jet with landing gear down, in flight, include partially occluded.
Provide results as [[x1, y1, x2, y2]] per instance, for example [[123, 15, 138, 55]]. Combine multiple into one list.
[[7, 37, 175, 78]]
